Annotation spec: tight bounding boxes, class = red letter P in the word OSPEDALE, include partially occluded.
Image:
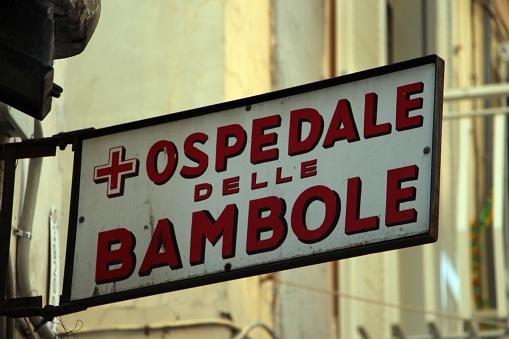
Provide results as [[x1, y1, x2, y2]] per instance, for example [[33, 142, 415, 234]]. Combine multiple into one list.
[[215, 124, 247, 172]]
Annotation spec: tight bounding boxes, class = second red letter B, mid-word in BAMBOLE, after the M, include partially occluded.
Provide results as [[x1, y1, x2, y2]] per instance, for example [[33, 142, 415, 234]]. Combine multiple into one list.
[[246, 196, 288, 255]]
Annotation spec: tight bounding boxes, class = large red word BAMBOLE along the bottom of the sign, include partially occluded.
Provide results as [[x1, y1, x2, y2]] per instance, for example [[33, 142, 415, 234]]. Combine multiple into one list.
[[95, 166, 418, 284]]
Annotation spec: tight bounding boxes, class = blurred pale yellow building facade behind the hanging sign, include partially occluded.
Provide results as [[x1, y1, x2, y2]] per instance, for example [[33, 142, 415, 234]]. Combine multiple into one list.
[[0, 0, 509, 339]]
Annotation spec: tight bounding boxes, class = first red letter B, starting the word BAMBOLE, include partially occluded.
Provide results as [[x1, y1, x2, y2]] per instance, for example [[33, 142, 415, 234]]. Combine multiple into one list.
[[95, 228, 136, 285]]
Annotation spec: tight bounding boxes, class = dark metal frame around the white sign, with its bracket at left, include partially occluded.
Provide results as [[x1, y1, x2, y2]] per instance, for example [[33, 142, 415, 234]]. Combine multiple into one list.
[[0, 55, 444, 316]]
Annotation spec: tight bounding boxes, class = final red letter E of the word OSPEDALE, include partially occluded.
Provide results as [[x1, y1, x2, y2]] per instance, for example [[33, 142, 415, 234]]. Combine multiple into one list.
[[396, 82, 424, 131]]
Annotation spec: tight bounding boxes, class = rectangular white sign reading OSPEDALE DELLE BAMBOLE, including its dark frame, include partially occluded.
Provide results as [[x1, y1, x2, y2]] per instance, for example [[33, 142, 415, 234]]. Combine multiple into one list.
[[63, 56, 443, 306]]
